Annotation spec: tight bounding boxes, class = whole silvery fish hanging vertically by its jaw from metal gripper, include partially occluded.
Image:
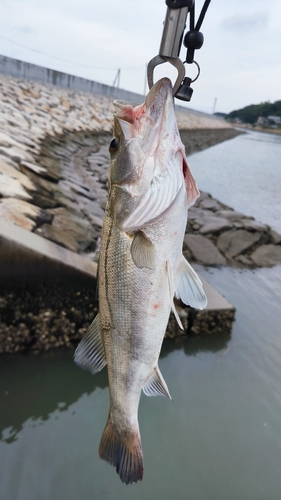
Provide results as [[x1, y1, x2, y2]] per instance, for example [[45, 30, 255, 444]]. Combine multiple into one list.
[[74, 78, 206, 484]]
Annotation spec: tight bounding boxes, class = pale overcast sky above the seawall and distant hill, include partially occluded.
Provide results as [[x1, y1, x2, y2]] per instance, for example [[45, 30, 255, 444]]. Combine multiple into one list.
[[0, 0, 281, 112]]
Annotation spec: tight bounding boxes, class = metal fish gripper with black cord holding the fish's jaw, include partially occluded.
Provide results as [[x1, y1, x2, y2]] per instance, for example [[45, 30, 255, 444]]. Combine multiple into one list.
[[147, 0, 211, 101]]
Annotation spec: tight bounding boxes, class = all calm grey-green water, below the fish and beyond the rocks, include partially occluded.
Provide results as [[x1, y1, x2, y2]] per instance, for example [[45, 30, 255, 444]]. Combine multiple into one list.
[[0, 133, 281, 500]]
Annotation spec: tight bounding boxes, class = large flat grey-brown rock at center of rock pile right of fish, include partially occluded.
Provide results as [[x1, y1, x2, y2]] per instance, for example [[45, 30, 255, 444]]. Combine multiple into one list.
[[217, 229, 261, 257]]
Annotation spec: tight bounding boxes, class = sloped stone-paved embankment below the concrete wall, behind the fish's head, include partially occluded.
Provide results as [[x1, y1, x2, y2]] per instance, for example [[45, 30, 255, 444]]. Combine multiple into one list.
[[0, 76, 241, 262]]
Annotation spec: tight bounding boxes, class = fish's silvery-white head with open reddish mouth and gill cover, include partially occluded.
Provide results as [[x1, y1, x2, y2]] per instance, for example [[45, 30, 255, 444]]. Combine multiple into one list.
[[109, 78, 199, 231]]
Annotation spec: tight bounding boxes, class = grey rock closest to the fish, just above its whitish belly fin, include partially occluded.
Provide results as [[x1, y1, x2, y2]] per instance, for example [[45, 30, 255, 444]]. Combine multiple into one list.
[[184, 234, 226, 266]]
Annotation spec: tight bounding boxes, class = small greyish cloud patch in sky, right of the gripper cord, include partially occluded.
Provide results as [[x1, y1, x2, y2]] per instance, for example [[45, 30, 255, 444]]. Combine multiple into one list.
[[221, 11, 269, 33]]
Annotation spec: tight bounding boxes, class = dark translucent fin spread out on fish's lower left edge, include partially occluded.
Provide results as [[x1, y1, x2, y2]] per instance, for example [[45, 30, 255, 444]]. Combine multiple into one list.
[[74, 315, 106, 374]]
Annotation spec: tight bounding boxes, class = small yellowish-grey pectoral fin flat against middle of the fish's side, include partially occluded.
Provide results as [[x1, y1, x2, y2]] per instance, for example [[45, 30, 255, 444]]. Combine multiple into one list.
[[131, 231, 156, 269]]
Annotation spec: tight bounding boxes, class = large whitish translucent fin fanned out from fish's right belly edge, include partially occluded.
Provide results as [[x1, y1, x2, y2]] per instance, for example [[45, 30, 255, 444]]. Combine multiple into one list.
[[175, 255, 207, 309]]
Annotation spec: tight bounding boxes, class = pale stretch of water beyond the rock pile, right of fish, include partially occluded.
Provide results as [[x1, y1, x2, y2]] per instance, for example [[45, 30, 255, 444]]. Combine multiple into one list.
[[189, 127, 281, 233]]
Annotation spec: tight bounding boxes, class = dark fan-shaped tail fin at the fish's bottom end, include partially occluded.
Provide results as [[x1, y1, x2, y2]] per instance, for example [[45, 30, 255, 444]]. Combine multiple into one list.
[[99, 416, 143, 484]]
